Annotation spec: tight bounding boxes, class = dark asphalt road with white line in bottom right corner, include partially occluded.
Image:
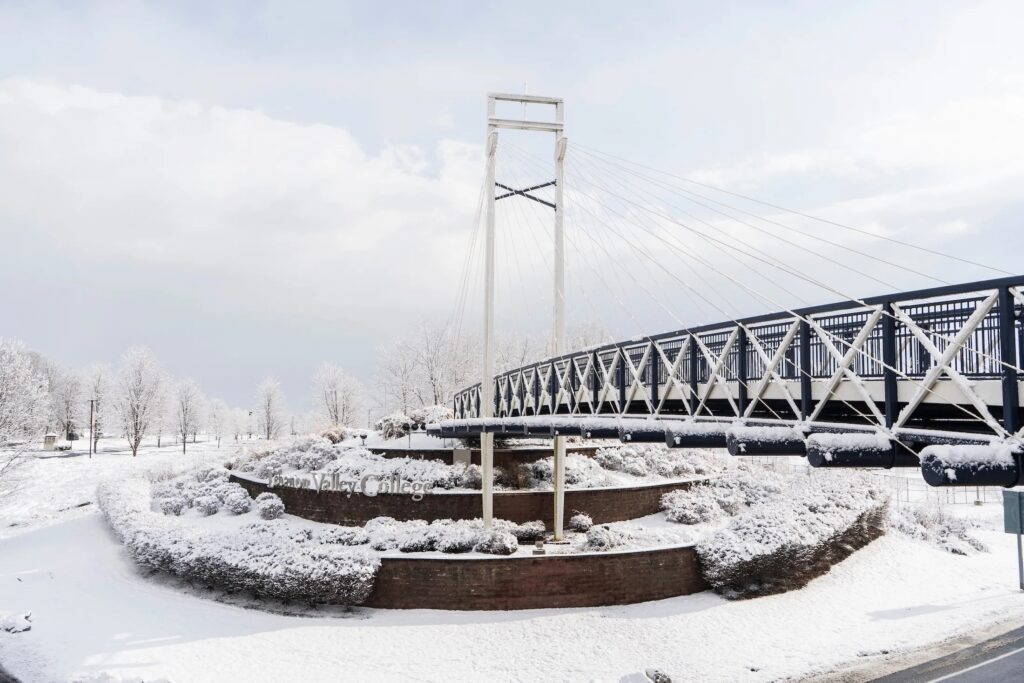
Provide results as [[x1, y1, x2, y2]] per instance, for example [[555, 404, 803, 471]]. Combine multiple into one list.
[[873, 628, 1024, 683]]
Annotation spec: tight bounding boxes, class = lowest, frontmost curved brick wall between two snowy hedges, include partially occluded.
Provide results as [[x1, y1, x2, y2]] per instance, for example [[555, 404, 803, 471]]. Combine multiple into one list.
[[366, 548, 708, 609]]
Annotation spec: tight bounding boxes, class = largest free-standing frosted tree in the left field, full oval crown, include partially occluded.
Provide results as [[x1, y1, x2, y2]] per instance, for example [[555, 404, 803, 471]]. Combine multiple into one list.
[[114, 347, 166, 457]]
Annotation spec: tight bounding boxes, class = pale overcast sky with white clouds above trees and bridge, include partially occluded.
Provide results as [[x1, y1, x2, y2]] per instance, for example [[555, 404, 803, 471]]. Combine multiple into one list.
[[0, 0, 1024, 411]]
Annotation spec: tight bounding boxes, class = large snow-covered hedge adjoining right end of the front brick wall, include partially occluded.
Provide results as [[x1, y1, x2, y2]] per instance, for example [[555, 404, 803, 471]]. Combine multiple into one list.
[[697, 472, 888, 598]]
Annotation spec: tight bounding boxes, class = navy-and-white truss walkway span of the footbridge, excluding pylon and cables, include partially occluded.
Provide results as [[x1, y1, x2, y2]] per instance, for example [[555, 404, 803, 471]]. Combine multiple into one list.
[[432, 275, 1024, 485]]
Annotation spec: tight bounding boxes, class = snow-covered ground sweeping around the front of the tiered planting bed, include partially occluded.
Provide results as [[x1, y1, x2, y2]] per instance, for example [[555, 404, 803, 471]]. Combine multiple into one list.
[[0, 444, 1024, 681]]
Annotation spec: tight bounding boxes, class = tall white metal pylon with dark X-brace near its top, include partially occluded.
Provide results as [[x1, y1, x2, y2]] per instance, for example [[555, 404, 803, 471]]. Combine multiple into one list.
[[478, 93, 566, 541]]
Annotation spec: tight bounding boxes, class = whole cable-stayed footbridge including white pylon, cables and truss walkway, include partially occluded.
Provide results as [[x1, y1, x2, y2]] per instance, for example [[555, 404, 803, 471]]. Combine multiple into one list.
[[429, 94, 1024, 497]]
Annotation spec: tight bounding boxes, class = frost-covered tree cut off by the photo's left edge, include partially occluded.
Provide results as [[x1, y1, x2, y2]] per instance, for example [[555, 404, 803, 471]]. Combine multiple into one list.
[[0, 340, 50, 443]]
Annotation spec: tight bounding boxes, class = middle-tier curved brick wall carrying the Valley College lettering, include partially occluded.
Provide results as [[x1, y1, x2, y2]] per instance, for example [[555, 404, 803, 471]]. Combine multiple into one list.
[[230, 474, 702, 528]]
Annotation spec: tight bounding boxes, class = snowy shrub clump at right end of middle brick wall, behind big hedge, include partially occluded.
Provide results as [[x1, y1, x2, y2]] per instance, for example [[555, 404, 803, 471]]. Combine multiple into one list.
[[662, 462, 783, 524]]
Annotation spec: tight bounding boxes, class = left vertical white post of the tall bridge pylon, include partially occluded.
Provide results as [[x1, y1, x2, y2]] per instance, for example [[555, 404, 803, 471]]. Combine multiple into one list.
[[479, 97, 498, 528]]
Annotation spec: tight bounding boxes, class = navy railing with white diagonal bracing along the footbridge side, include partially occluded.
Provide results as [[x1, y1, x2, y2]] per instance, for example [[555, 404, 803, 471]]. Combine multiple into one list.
[[454, 276, 1024, 433]]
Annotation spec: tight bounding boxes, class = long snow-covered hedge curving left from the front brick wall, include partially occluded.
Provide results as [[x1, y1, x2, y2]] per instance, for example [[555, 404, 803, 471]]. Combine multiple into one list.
[[97, 479, 380, 604]]
